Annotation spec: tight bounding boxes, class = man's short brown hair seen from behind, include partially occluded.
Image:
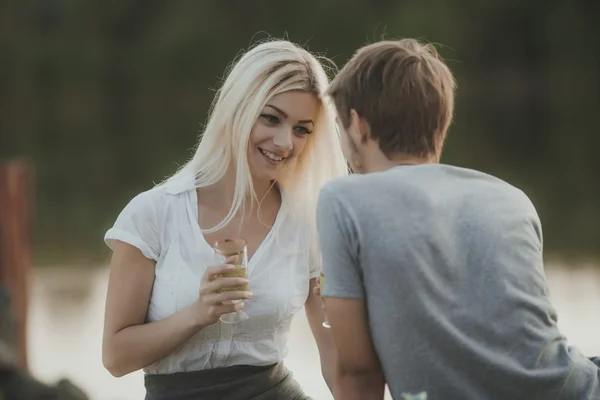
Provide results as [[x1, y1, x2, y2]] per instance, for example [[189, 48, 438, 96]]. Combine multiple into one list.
[[326, 39, 456, 157]]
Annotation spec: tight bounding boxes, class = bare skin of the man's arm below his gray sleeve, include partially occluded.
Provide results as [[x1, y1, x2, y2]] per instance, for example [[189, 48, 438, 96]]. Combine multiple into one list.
[[325, 297, 385, 400]]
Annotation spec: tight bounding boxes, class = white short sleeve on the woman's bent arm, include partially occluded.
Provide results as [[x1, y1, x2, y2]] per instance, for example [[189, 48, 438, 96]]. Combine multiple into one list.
[[104, 190, 160, 261]]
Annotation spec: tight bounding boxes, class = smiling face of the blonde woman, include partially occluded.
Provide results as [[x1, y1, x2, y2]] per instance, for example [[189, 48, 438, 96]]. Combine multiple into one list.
[[248, 91, 319, 180]]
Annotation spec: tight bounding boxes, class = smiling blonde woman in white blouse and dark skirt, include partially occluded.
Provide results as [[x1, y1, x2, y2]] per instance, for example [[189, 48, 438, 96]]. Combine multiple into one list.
[[102, 41, 347, 400]]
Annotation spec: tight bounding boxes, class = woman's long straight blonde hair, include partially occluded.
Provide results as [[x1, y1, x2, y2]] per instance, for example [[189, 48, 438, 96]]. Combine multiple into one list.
[[167, 40, 348, 263]]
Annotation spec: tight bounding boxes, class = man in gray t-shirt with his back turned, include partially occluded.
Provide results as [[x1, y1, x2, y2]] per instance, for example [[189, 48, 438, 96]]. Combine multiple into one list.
[[318, 39, 600, 400]]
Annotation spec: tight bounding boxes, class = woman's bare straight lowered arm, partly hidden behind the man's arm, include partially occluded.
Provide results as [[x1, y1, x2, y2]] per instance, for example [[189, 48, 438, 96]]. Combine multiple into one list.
[[304, 278, 337, 393]]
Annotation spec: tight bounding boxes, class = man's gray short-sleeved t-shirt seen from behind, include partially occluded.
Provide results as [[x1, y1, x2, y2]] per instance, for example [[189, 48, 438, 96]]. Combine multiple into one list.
[[318, 164, 600, 400]]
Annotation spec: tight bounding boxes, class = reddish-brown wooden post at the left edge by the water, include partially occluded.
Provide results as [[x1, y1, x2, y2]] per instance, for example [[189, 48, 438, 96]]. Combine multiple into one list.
[[0, 160, 33, 369]]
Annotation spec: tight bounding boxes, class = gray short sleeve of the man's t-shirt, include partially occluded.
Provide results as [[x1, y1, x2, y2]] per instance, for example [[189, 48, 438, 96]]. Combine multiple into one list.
[[317, 185, 365, 299]]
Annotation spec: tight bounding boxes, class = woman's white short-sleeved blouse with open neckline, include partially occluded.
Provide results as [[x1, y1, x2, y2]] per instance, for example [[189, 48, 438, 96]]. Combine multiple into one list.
[[104, 174, 319, 374]]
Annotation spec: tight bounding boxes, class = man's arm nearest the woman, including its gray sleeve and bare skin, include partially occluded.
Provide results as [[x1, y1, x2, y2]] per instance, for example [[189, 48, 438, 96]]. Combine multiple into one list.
[[317, 184, 385, 400]]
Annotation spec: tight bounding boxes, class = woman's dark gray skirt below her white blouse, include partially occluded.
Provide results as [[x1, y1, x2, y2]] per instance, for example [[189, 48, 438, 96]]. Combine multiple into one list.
[[144, 362, 311, 400]]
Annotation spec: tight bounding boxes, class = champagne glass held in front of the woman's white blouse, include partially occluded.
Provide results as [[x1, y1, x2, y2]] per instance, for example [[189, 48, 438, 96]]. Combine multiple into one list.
[[213, 238, 249, 324]]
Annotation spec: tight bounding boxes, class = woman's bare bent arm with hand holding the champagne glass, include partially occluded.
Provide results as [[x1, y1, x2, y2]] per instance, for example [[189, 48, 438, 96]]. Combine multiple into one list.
[[102, 241, 249, 377]]
